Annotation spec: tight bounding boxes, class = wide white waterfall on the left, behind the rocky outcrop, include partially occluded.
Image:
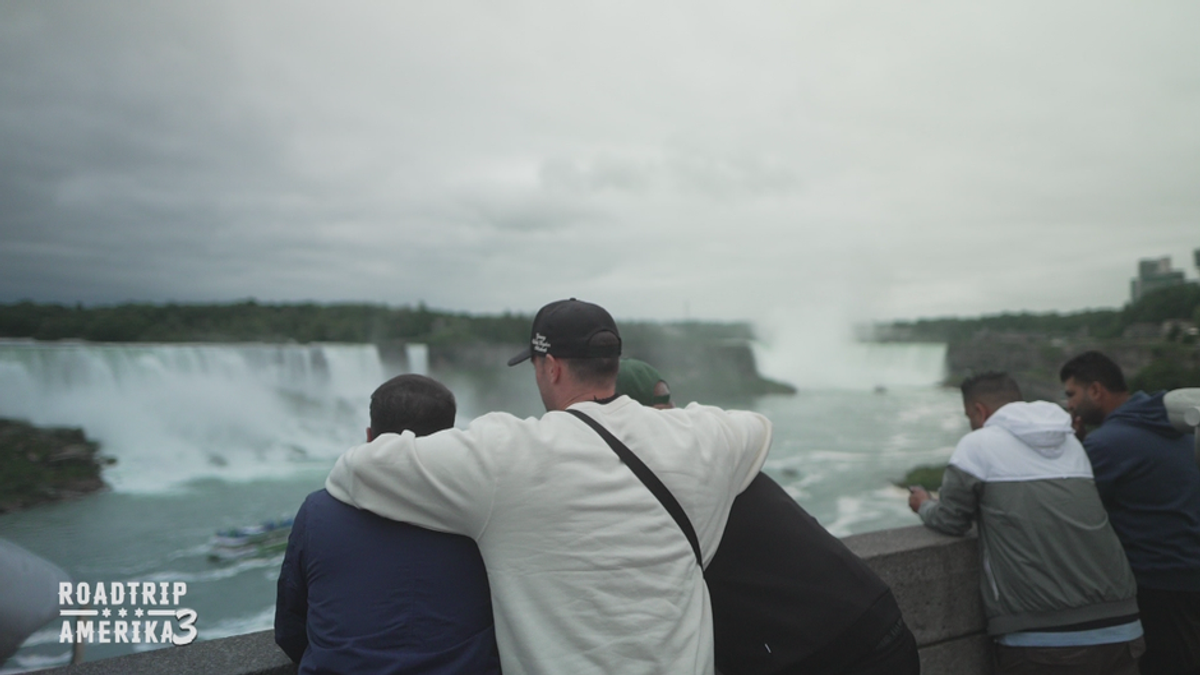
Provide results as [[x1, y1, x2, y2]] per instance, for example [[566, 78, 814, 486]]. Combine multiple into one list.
[[0, 341, 384, 491]]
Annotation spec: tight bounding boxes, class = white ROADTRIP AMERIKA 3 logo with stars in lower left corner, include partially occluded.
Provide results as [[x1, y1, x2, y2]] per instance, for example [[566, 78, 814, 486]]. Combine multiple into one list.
[[59, 581, 197, 645]]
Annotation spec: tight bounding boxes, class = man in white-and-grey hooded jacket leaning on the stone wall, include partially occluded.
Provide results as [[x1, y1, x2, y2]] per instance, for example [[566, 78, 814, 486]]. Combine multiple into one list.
[[908, 372, 1145, 675]]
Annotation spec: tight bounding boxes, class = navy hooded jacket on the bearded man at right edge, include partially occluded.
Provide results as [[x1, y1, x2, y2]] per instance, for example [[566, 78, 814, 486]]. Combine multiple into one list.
[[1084, 392, 1200, 591]]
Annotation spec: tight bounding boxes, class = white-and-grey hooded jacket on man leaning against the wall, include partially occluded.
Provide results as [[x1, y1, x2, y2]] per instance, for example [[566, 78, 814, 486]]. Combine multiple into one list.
[[920, 401, 1138, 635]]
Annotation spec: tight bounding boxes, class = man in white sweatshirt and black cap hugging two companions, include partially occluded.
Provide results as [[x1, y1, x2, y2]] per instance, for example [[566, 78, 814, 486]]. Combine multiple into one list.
[[325, 298, 770, 675]]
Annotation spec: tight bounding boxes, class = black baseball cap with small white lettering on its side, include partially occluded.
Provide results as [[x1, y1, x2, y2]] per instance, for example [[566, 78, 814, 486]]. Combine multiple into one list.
[[509, 298, 620, 365]]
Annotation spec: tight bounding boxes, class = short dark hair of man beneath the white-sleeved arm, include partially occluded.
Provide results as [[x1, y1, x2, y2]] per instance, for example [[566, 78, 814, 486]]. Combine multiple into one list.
[[371, 374, 457, 436]]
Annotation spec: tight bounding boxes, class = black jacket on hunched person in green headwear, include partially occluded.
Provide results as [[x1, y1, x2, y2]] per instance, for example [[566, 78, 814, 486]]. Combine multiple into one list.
[[704, 473, 900, 675]]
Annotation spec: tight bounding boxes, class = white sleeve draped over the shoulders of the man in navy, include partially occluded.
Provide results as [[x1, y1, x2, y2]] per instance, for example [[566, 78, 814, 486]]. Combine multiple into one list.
[[325, 413, 501, 539]]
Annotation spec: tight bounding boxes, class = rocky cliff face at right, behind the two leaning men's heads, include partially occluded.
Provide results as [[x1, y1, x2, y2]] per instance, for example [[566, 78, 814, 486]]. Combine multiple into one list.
[[946, 333, 1200, 401]]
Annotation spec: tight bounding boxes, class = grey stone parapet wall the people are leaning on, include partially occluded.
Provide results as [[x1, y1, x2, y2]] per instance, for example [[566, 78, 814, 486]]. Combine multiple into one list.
[[48, 525, 991, 675]]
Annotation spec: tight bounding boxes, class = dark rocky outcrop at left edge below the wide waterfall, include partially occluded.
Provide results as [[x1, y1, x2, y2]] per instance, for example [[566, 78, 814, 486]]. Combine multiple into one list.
[[0, 419, 116, 513]]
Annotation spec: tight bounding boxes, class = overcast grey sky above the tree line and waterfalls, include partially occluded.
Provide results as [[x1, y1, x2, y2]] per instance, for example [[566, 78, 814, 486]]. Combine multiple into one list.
[[0, 0, 1200, 323]]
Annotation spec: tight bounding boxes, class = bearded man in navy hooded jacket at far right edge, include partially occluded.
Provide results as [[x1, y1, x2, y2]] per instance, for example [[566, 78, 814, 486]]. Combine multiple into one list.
[[1058, 352, 1200, 675]]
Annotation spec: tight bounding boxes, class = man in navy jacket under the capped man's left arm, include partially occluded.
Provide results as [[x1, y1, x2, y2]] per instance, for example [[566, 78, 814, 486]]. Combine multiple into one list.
[[275, 375, 500, 675]]
